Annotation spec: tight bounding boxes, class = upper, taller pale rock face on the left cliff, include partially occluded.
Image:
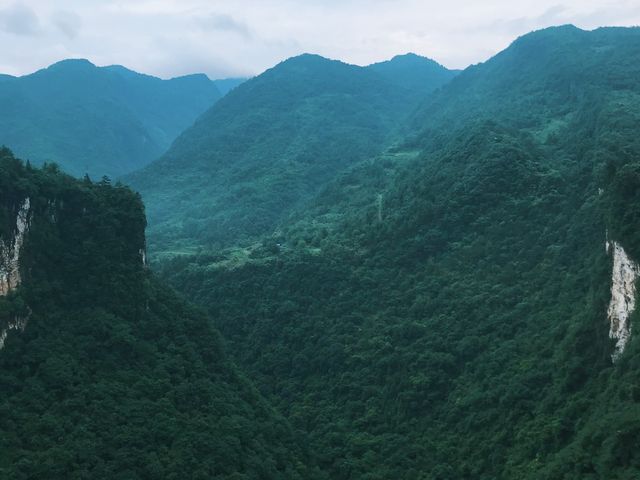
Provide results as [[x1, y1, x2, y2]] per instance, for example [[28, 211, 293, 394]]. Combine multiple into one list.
[[0, 198, 31, 296]]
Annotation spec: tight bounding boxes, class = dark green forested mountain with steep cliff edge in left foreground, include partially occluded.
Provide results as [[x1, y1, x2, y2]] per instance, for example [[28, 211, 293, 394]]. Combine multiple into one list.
[[0, 149, 322, 479]]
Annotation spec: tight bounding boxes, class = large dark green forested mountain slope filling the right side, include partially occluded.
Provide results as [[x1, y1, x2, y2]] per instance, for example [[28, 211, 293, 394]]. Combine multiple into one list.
[[150, 26, 640, 480]]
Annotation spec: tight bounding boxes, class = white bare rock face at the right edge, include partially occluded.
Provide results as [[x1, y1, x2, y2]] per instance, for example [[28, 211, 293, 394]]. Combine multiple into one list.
[[607, 242, 640, 362]]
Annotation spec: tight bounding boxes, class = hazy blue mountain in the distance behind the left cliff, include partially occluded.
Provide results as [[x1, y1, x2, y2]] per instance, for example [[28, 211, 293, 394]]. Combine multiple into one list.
[[0, 60, 220, 178]]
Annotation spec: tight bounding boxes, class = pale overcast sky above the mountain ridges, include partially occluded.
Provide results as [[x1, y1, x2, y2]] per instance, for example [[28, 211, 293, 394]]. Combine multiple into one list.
[[0, 0, 640, 78]]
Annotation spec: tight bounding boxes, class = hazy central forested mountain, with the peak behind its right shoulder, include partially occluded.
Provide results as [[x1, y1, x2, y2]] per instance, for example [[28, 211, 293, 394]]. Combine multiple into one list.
[[126, 55, 453, 252]]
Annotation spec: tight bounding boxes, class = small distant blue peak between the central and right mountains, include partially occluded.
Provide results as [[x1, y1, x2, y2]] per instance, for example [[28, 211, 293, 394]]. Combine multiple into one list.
[[367, 53, 459, 91]]
